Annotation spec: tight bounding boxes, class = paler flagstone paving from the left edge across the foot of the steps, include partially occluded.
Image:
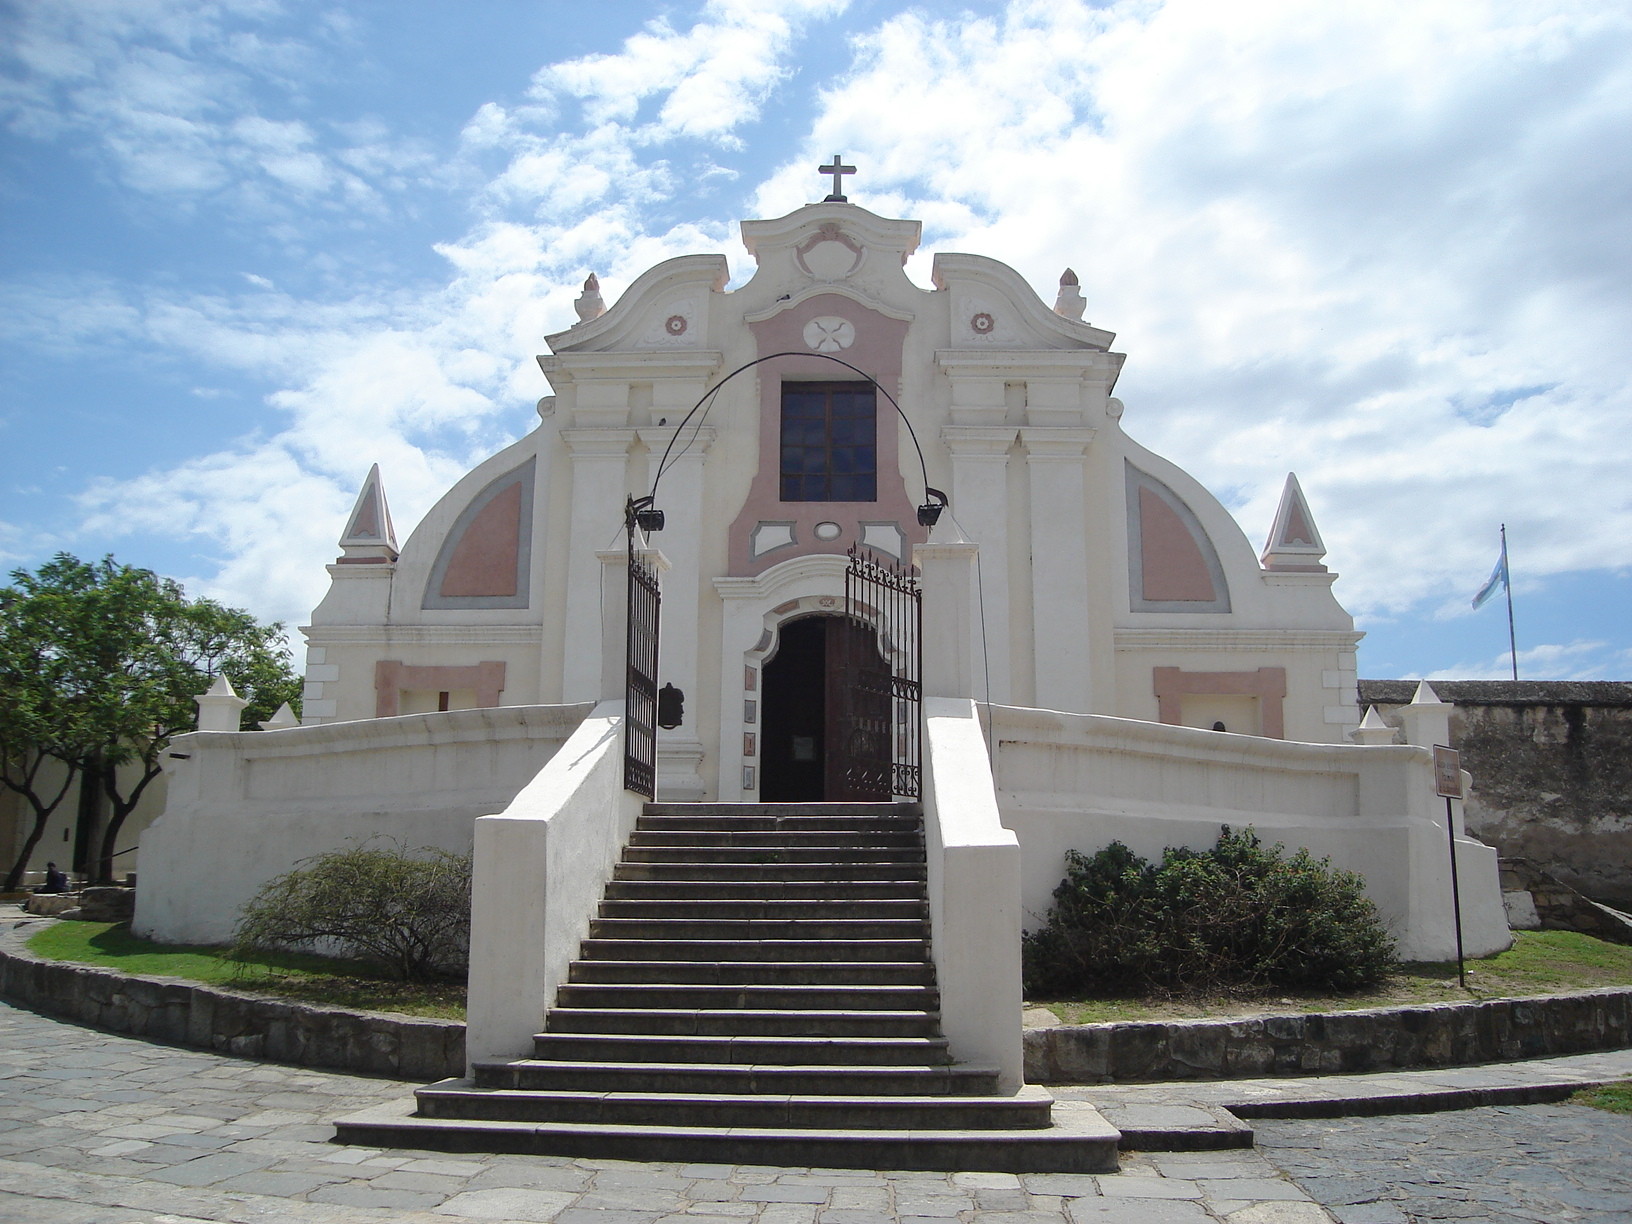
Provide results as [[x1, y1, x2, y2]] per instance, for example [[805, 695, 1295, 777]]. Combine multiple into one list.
[[0, 1004, 1332, 1224]]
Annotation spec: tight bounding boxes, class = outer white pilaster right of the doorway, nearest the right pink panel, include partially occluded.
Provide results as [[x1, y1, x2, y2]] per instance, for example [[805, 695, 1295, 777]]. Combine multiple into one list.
[[1020, 426, 1093, 713]]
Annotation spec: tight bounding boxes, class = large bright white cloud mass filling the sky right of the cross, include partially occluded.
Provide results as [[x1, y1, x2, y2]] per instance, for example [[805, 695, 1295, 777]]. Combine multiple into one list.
[[773, 0, 1632, 626]]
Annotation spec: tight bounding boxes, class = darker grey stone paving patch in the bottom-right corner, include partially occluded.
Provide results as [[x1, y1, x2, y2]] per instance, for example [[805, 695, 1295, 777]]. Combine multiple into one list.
[[1253, 1105, 1632, 1224]]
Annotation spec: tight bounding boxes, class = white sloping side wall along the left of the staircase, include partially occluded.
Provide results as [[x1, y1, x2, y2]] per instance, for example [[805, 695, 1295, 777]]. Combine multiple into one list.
[[465, 702, 643, 1061]]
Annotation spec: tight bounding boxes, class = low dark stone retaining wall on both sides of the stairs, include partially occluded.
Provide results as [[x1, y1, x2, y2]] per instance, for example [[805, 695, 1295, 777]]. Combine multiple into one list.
[[0, 929, 1632, 1084]]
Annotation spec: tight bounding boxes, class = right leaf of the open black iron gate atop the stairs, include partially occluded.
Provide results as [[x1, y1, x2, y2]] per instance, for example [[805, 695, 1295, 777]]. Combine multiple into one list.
[[829, 548, 924, 800]]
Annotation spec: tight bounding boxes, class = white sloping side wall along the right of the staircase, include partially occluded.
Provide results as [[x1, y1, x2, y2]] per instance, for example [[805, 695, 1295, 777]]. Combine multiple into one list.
[[924, 697, 1025, 1092]]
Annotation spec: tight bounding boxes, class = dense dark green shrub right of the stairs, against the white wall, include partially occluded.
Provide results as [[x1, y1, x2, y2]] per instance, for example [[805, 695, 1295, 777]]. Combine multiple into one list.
[[1022, 826, 1395, 997]]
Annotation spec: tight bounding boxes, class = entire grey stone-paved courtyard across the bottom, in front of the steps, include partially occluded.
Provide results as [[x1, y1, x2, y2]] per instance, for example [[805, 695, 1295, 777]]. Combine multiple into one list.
[[0, 1004, 1632, 1224]]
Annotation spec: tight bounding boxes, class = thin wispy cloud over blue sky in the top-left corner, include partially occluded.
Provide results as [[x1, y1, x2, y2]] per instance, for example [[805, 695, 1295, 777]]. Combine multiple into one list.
[[0, 0, 441, 214]]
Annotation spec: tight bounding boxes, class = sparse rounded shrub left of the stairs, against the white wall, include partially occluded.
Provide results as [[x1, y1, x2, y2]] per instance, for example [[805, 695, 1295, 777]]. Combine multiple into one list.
[[233, 845, 470, 981]]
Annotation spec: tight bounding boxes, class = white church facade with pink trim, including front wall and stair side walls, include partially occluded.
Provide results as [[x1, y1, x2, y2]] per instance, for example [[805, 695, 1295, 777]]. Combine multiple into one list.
[[137, 174, 1508, 1084]]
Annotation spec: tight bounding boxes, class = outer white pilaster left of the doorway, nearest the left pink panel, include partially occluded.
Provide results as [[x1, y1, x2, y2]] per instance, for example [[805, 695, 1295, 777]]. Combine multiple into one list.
[[561, 428, 635, 702]]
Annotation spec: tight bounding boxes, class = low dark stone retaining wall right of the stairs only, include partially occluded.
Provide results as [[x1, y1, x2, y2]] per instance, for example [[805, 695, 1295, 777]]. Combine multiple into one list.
[[1025, 987, 1632, 1084]]
